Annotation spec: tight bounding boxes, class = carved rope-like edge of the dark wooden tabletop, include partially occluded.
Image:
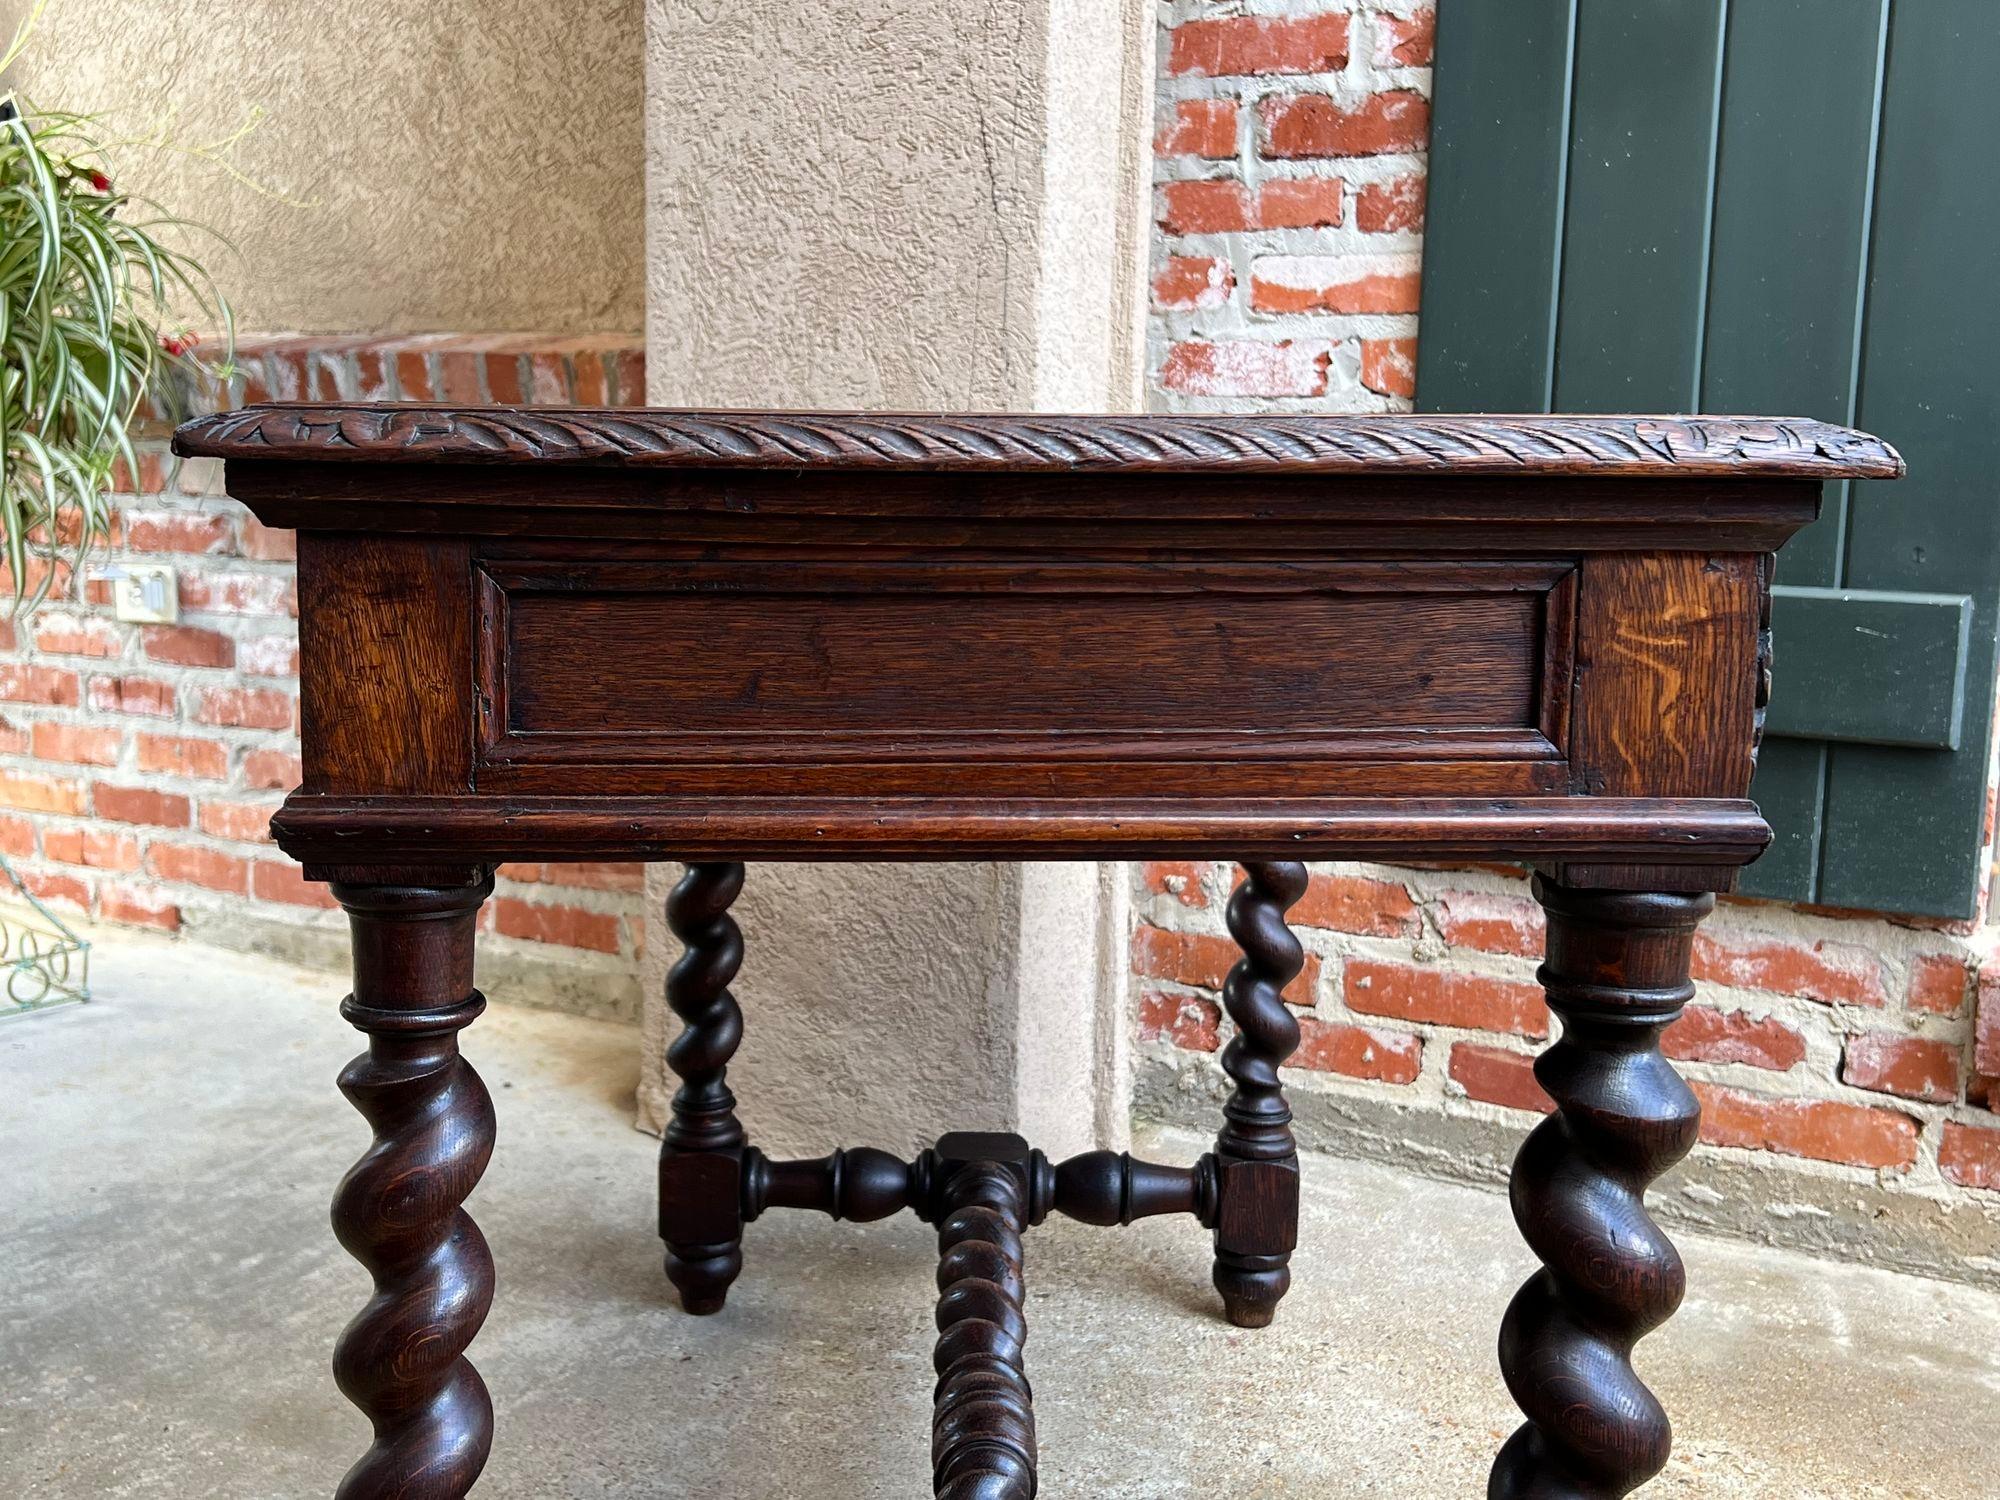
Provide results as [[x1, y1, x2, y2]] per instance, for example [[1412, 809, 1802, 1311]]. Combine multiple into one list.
[[174, 404, 1904, 480]]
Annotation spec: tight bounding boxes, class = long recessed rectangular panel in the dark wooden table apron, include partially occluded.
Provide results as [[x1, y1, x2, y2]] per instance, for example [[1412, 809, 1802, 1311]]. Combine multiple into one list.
[[504, 564, 1546, 740]]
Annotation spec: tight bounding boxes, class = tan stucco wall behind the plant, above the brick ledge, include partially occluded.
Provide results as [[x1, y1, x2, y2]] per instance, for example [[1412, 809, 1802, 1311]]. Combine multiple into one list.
[[0, 0, 644, 334]]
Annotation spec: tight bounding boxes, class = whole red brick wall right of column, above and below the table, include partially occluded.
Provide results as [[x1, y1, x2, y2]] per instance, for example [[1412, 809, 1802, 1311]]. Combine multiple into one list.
[[1132, 0, 2000, 1200]]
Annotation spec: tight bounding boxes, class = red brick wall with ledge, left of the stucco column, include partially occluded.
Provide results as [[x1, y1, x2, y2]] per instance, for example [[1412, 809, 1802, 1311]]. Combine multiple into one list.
[[0, 334, 646, 1004]]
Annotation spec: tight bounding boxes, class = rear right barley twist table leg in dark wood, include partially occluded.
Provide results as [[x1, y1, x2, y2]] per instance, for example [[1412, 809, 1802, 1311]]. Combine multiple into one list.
[[1214, 862, 1306, 1328]]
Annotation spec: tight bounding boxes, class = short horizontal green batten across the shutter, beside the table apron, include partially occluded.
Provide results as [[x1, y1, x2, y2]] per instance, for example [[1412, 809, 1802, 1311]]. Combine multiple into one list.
[[1764, 584, 1972, 750]]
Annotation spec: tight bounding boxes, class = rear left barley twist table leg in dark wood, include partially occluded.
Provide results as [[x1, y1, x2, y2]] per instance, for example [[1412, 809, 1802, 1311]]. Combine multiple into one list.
[[660, 864, 744, 1314]]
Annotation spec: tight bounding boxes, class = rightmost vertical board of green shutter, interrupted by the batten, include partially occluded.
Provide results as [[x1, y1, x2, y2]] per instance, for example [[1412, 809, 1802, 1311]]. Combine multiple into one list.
[[1820, 0, 2000, 916]]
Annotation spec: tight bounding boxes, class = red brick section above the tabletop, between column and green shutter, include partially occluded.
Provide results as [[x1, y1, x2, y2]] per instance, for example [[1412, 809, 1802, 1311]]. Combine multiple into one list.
[[1148, 0, 1434, 412]]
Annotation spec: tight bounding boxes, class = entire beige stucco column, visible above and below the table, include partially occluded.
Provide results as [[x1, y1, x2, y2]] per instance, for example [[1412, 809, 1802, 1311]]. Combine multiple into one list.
[[640, 0, 1152, 1152]]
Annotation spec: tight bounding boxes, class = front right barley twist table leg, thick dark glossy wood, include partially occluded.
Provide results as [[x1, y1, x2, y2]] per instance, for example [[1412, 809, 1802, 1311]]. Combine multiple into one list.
[[1488, 878, 1714, 1500]]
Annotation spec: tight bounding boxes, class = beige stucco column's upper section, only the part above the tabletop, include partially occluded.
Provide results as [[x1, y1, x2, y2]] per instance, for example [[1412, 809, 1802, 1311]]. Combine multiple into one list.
[[646, 0, 1150, 410]]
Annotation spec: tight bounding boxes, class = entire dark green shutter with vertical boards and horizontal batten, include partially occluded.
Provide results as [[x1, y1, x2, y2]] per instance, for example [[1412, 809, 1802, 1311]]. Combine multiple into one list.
[[1418, 0, 2000, 916]]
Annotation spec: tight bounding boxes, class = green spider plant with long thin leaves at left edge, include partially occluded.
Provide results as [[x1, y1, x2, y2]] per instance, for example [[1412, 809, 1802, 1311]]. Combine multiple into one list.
[[0, 40, 234, 610]]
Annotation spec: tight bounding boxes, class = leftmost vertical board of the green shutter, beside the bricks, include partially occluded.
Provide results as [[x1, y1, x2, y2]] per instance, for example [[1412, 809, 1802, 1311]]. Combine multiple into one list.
[[1422, 0, 1576, 412]]
